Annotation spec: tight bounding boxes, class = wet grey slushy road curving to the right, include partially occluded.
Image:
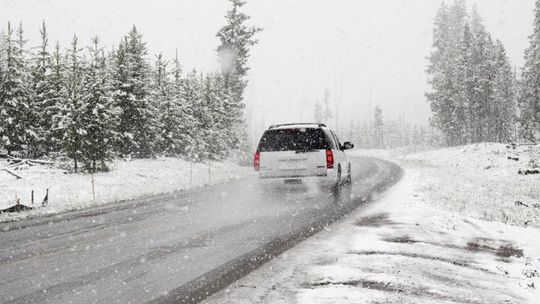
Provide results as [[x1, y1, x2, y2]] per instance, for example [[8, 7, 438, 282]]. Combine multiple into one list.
[[0, 158, 401, 303]]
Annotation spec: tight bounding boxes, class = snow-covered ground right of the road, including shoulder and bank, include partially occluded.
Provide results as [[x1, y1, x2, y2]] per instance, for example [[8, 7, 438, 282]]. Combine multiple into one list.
[[206, 144, 540, 304]]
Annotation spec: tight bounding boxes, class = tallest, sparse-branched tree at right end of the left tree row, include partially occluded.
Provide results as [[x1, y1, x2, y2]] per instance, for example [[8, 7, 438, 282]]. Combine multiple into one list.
[[216, 0, 262, 159]]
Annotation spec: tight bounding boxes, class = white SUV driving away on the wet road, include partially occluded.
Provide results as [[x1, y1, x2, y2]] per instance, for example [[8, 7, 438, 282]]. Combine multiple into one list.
[[253, 123, 354, 193]]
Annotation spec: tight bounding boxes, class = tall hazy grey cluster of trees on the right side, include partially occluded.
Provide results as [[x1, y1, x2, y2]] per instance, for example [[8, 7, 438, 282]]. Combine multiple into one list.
[[426, 0, 540, 145]]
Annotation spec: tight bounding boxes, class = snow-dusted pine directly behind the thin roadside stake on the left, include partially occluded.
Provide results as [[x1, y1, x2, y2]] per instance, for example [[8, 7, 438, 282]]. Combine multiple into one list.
[[80, 37, 118, 173]]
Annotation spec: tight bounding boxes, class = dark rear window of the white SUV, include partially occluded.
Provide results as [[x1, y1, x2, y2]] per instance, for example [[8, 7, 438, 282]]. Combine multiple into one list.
[[258, 128, 331, 152]]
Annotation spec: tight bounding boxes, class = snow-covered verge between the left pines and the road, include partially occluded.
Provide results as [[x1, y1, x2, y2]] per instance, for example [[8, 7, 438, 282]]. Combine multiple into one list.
[[0, 158, 252, 221]]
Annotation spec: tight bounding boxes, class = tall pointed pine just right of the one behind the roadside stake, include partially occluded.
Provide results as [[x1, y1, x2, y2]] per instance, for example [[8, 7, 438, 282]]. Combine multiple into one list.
[[112, 26, 158, 158]]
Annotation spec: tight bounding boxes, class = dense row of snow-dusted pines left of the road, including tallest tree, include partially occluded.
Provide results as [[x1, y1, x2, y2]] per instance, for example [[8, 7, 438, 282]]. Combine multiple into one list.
[[0, 0, 260, 171]]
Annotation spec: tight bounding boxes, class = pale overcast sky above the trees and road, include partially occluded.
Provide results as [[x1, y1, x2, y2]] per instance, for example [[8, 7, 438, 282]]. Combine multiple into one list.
[[0, 0, 534, 138]]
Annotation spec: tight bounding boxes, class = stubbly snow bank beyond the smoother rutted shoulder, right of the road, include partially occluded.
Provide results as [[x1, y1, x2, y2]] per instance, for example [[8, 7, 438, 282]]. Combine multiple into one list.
[[394, 143, 540, 226]]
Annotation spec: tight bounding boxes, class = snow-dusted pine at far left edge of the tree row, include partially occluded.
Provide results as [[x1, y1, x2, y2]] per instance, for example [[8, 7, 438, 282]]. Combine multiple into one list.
[[0, 23, 35, 154]]
